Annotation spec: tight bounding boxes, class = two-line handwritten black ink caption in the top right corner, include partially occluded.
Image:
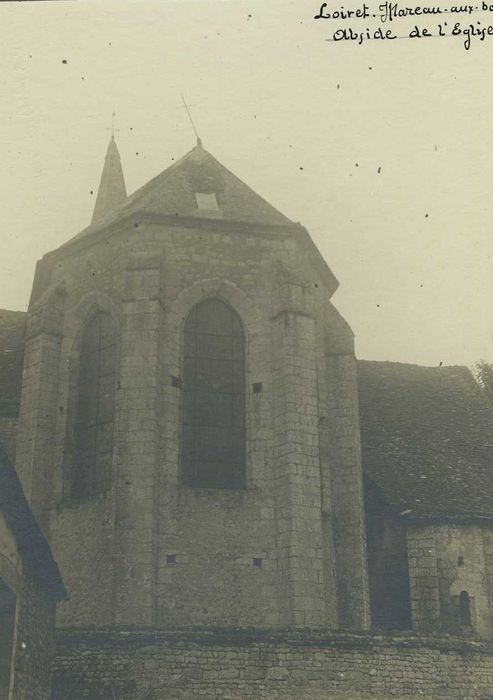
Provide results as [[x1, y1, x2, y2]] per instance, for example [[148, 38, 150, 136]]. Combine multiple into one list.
[[314, 0, 493, 51]]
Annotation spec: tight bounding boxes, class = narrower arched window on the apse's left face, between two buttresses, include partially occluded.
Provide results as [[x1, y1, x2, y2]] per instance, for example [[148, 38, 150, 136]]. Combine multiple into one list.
[[71, 312, 117, 500]]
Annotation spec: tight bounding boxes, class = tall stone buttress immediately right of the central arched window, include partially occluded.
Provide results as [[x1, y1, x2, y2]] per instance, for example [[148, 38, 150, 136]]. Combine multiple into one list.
[[273, 273, 326, 626]]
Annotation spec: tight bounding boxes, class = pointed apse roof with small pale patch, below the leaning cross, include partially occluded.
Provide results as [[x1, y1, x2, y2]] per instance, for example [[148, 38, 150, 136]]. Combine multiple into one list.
[[72, 143, 293, 245]]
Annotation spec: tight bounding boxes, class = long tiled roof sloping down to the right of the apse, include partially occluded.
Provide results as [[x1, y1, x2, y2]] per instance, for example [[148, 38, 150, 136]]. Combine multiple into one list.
[[358, 361, 493, 516]]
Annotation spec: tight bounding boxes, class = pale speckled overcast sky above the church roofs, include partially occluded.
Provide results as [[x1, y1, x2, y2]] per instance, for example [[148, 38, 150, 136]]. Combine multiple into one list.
[[0, 0, 493, 365]]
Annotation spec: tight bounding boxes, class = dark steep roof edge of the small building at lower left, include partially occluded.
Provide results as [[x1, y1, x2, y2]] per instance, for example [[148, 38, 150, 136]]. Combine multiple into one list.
[[0, 445, 67, 600]]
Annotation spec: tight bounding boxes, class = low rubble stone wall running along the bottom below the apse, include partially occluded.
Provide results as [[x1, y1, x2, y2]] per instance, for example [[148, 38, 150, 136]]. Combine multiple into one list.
[[52, 629, 493, 700]]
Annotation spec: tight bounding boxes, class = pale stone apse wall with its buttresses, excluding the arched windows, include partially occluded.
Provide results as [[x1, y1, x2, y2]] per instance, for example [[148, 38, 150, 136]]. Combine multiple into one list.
[[23, 221, 367, 627]]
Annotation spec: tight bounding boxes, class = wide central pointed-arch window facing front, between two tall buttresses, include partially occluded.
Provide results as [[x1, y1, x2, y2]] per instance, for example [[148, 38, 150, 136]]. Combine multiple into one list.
[[181, 298, 245, 489]]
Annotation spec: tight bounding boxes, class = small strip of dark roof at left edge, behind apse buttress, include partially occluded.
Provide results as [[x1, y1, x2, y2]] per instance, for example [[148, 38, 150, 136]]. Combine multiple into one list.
[[0, 309, 26, 416]]
